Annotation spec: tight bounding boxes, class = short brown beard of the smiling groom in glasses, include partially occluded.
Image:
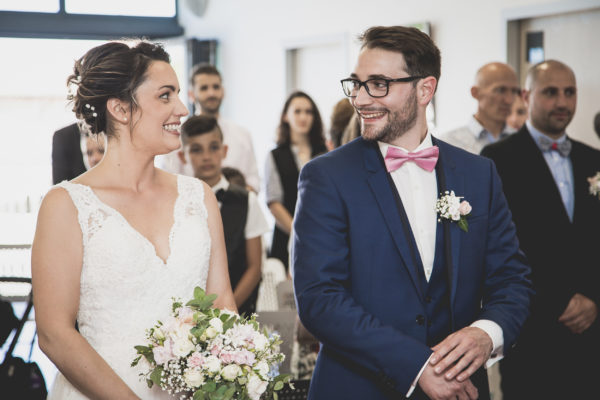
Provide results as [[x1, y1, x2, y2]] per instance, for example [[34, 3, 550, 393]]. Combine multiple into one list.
[[360, 89, 417, 143]]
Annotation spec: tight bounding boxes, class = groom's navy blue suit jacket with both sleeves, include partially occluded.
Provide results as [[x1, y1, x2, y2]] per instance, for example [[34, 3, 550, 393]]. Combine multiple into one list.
[[292, 138, 532, 399]]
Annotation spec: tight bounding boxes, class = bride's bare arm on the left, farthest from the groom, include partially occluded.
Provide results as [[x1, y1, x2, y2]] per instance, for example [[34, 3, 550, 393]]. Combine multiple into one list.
[[31, 189, 138, 399]]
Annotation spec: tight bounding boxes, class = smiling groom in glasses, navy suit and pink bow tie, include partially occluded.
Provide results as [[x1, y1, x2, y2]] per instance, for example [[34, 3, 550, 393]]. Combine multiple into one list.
[[292, 26, 532, 400]]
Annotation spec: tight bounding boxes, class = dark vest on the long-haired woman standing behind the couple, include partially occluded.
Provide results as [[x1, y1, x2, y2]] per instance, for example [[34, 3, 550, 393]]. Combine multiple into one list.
[[269, 145, 300, 270]]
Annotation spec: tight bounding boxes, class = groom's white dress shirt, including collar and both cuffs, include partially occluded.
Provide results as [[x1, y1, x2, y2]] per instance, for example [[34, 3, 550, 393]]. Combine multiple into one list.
[[378, 132, 504, 397]]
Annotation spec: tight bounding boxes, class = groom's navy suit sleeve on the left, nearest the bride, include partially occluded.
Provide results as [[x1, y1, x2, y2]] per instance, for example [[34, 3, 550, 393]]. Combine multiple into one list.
[[292, 159, 432, 395]]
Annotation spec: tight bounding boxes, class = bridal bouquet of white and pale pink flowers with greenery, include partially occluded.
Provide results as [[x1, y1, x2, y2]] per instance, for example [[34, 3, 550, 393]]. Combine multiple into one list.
[[131, 287, 290, 400]]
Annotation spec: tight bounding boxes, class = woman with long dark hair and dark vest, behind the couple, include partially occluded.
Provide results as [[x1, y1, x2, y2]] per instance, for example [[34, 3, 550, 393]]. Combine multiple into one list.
[[265, 91, 327, 271]]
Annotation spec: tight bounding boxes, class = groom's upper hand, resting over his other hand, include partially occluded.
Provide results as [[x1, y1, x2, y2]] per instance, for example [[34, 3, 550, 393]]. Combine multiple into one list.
[[429, 326, 493, 382]]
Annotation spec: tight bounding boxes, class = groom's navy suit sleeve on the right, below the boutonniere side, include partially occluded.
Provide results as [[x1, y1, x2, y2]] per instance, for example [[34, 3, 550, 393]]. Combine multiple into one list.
[[480, 161, 533, 348]]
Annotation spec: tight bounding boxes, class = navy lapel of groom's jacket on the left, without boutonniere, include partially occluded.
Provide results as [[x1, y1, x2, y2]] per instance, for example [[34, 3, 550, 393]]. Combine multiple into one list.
[[364, 141, 424, 300]]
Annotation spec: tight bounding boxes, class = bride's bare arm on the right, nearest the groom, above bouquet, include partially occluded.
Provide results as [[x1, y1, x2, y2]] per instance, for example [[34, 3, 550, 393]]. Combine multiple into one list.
[[202, 182, 237, 311]]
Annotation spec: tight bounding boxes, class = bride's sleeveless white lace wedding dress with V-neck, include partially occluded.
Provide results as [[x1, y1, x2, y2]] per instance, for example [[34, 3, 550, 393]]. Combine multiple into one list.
[[48, 175, 210, 400]]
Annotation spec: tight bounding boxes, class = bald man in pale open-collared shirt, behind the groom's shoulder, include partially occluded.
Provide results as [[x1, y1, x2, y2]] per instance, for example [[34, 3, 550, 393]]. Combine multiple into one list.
[[440, 62, 521, 154]]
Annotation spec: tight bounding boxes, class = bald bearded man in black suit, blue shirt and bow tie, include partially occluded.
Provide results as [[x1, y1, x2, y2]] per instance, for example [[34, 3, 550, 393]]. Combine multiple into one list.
[[482, 60, 600, 400]]
